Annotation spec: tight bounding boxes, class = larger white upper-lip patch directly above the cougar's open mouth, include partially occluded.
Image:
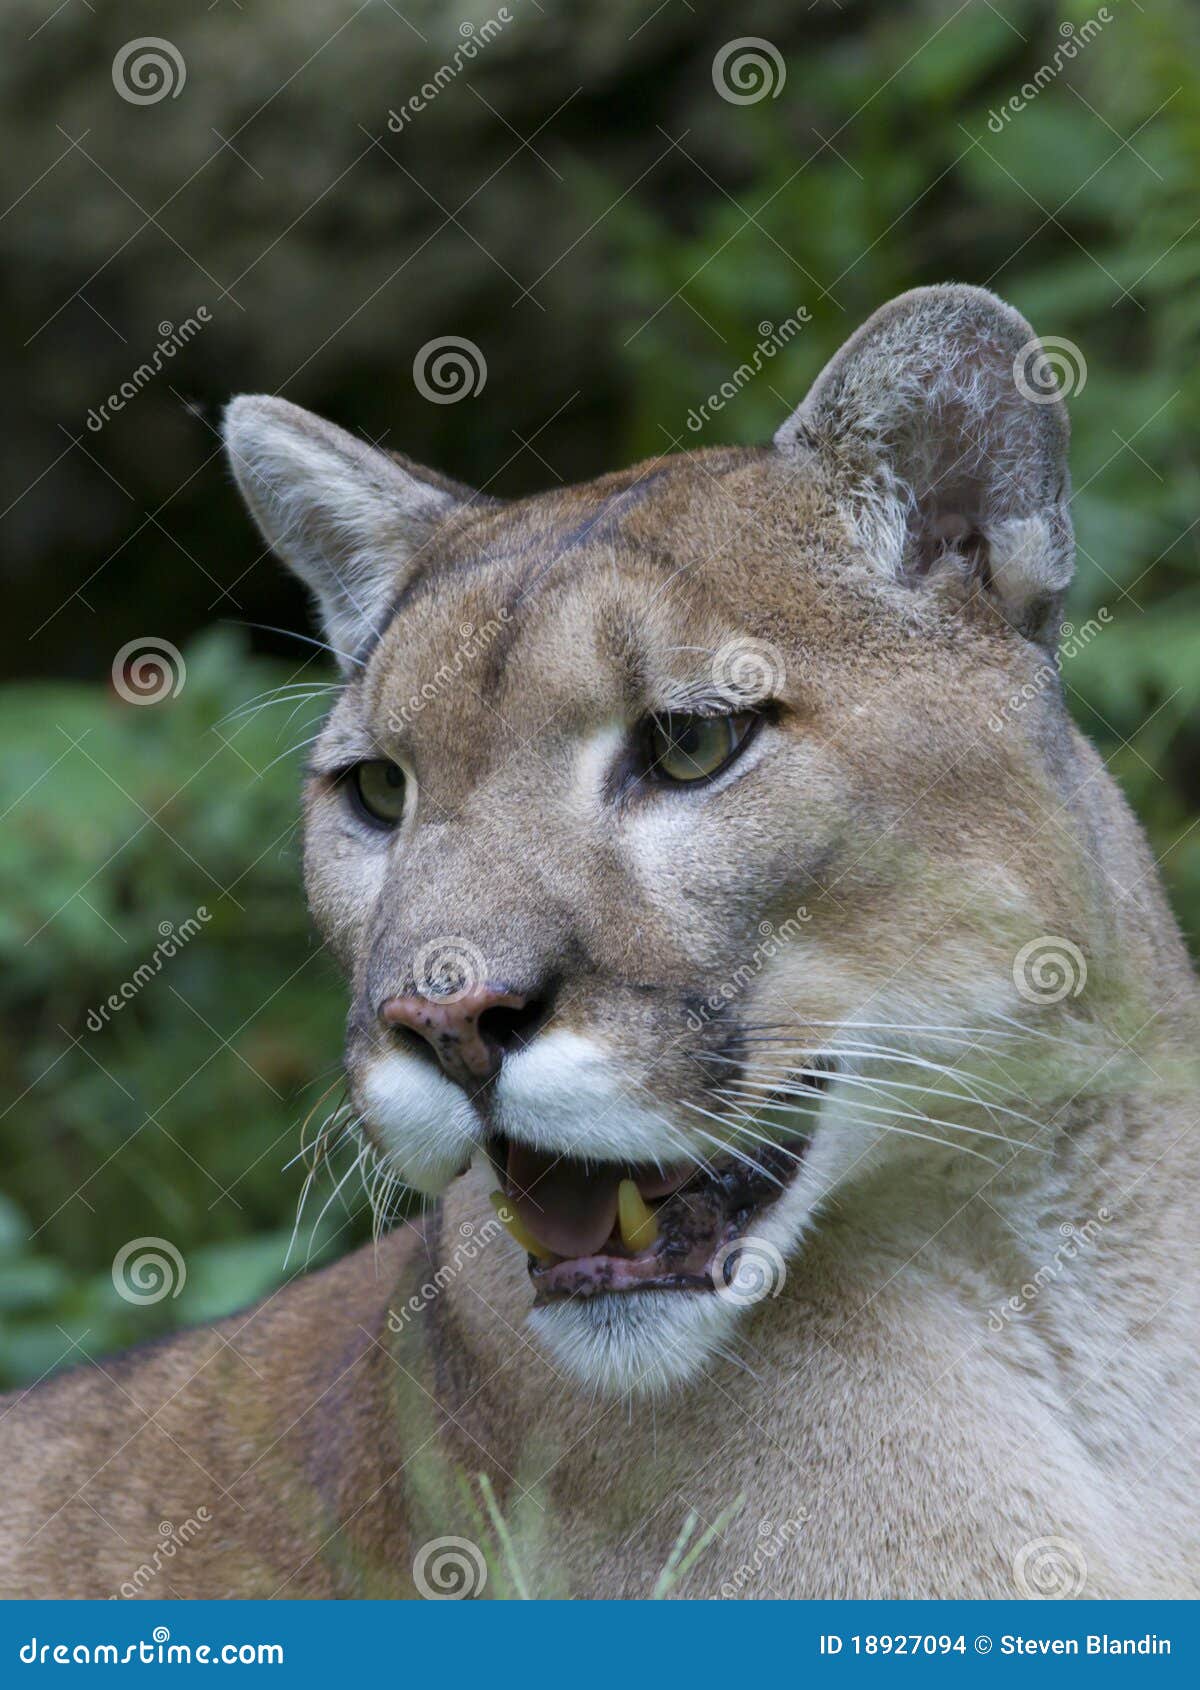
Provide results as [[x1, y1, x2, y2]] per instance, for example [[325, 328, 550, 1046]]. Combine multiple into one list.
[[495, 1031, 679, 1163]]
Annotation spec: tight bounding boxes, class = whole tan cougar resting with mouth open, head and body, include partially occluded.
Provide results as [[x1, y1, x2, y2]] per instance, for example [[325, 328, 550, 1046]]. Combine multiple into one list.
[[0, 286, 1200, 1597]]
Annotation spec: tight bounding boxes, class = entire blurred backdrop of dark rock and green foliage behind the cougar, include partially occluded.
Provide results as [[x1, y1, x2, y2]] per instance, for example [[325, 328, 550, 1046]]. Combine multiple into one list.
[[0, 0, 1200, 1381]]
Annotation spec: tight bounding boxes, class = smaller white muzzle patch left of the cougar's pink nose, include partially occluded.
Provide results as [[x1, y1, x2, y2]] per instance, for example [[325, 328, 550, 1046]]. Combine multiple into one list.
[[358, 1051, 478, 1197]]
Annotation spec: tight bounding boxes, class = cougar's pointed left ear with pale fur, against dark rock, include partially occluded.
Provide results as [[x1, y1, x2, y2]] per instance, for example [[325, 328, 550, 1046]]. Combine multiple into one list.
[[225, 394, 477, 673]]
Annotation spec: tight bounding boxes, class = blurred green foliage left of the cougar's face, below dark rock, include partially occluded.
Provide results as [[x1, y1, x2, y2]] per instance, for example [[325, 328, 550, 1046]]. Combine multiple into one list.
[[0, 632, 360, 1381]]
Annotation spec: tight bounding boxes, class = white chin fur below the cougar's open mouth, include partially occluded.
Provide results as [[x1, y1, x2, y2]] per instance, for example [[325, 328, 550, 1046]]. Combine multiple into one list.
[[529, 1291, 740, 1398]]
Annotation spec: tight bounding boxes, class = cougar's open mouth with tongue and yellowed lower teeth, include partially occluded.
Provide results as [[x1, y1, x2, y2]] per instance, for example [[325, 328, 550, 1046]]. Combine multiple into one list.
[[487, 1074, 828, 1308]]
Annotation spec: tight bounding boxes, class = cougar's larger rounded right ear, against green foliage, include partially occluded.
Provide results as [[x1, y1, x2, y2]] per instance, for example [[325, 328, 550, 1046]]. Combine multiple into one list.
[[776, 286, 1073, 646]]
